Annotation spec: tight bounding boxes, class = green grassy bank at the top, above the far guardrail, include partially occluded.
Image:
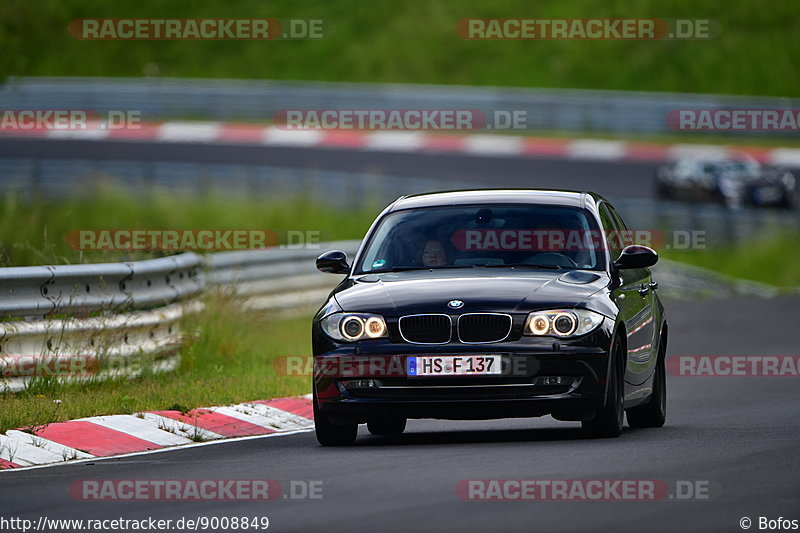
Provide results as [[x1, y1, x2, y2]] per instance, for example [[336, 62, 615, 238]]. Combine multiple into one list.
[[0, 0, 800, 96]]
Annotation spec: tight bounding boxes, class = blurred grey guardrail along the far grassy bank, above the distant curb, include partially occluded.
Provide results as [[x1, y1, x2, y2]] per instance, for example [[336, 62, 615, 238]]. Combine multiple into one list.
[[0, 77, 800, 135]]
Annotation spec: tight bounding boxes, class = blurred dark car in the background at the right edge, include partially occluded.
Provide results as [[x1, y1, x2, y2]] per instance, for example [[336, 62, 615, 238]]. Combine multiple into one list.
[[656, 158, 797, 209]]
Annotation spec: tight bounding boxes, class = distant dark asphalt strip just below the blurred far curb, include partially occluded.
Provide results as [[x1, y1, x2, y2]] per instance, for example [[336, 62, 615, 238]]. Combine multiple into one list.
[[0, 138, 656, 198]]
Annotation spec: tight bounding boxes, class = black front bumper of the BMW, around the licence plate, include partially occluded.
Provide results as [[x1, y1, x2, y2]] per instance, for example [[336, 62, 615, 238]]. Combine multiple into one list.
[[314, 346, 608, 424]]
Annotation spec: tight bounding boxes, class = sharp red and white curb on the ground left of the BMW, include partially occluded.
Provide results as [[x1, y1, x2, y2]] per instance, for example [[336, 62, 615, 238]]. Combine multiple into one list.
[[0, 395, 314, 471]]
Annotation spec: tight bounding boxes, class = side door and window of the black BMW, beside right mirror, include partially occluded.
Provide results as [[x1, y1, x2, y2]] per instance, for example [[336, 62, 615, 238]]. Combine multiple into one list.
[[600, 202, 658, 390]]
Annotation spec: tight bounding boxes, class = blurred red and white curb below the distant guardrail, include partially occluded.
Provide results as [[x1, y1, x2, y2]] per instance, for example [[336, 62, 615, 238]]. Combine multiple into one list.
[[0, 121, 800, 167]]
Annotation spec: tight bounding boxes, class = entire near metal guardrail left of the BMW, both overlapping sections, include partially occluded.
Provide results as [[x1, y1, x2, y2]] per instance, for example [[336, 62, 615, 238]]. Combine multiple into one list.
[[0, 241, 359, 392]]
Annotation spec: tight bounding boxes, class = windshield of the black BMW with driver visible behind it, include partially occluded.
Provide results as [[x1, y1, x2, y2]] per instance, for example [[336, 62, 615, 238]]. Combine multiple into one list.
[[355, 204, 604, 274]]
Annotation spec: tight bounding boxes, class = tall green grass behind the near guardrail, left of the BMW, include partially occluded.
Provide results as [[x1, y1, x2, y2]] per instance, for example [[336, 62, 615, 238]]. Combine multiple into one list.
[[0, 182, 376, 267]]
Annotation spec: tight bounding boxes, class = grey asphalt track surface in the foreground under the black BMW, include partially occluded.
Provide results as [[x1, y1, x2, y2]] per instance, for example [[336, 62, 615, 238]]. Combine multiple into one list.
[[0, 296, 800, 532]]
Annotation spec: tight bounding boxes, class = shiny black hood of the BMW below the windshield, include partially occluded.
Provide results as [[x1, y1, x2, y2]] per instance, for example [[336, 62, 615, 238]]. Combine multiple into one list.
[[335, 269, 609, 316]]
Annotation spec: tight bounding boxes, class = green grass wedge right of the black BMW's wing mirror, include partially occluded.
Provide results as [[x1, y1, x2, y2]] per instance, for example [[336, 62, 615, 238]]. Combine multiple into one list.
[[662, 232, 800, 288]]
